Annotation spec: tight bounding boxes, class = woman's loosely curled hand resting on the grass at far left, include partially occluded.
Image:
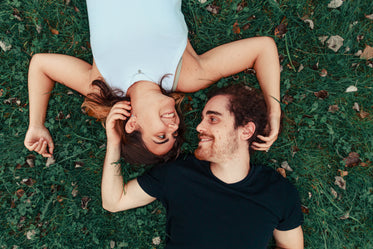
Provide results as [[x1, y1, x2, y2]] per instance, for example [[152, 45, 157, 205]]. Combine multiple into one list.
[[24, 125, 54, 157]]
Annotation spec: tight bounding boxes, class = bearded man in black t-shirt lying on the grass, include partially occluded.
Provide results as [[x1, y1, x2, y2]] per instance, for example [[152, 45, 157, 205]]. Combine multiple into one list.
[[102, 85, 303, 249]]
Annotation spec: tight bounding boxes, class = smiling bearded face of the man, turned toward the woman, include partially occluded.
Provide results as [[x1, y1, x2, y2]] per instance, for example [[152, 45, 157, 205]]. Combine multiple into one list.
[[194, 95, 239, 163]]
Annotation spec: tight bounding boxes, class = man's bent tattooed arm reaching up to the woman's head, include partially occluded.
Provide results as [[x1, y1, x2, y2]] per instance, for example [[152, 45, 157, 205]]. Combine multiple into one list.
[[101, 101, 155, 212]]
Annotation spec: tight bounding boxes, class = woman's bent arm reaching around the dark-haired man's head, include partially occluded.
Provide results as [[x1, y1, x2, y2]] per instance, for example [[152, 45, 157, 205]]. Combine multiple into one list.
[[177, 37, 281, 150]]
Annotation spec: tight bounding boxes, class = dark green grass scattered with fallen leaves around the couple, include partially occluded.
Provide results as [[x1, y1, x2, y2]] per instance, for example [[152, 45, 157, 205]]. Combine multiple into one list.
[[0, 0, 373, 249]]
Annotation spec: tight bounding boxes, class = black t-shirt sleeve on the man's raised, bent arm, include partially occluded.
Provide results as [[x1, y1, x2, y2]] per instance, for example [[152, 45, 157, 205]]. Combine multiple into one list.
[[137, 165, 168, 200]]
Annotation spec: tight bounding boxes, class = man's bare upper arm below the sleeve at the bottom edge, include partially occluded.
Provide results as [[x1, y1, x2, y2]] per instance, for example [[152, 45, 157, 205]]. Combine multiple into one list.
[[273, 226, 304, 249]]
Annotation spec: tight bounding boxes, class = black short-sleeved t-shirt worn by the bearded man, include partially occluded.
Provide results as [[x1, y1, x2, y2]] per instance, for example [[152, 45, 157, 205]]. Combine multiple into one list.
[[138, 156, 303, 249]]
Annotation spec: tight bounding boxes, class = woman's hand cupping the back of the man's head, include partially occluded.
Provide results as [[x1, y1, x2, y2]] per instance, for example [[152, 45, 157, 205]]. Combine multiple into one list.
[[251, 115, 281, 152]]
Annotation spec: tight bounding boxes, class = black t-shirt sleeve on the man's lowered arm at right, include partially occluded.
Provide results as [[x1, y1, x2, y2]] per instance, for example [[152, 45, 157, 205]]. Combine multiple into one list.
[[276, 183, 303, 231]]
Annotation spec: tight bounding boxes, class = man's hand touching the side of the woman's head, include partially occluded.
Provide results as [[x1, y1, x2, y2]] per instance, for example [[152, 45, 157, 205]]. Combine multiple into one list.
[[105, 101, 131, 145]]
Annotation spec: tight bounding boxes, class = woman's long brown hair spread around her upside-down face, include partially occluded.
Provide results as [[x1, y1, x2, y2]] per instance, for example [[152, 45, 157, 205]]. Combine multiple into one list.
[[82, 79, 185, 164]]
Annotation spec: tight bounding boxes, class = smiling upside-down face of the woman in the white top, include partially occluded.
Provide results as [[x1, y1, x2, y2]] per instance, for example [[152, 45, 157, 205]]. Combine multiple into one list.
[[132, 94, 180, 155]]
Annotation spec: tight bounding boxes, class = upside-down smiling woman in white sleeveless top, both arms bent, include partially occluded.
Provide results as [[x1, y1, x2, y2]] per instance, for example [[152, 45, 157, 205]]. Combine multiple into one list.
[[25, 0, 281, 163]]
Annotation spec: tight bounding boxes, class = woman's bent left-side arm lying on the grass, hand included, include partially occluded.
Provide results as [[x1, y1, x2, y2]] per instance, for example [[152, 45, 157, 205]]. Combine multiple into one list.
[[24, 54, 97, 157]]
